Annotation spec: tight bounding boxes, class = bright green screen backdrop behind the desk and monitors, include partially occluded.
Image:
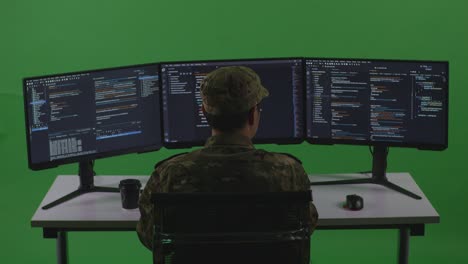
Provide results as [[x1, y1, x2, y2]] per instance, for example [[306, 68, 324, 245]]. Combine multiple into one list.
[[0, 0, 468, 264]]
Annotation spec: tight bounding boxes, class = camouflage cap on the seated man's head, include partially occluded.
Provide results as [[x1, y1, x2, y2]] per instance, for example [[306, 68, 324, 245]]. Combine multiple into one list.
[[200, 66, 269, 115]]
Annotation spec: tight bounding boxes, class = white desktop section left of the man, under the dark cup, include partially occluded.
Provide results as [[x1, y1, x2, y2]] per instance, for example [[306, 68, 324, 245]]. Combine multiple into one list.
[[31, 175, 148, 230]]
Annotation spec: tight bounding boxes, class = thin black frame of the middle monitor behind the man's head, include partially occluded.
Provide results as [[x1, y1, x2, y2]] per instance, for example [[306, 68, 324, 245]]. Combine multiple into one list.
[[159, 57, 306, 149]]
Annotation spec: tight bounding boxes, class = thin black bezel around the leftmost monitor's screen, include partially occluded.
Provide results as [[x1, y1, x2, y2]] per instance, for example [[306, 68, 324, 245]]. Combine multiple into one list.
[[23, 63, 164, 170]]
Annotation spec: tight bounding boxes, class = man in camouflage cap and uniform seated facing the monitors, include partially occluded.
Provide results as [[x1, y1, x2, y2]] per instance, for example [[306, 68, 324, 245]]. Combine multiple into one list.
[[137, 66, 318, 258]]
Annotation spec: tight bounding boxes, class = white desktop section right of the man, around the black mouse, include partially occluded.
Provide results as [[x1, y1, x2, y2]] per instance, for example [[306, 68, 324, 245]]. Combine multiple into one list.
[[309, 173, 439, 228]]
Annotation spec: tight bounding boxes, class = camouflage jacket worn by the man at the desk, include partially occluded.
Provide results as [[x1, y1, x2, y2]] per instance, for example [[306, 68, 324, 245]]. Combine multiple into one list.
[[137, 134, 318, 253]]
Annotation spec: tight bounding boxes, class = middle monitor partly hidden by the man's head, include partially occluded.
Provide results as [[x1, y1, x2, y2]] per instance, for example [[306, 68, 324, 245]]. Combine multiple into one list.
[[161, 58, 304, 148]]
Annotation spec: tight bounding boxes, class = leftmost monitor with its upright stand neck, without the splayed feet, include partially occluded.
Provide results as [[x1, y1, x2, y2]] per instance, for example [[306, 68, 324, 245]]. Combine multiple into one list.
[[23, 64, 162, 208]]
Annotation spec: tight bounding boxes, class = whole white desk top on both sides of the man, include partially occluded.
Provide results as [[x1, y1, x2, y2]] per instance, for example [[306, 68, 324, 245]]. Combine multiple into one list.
[[31, 173, 439, 230]]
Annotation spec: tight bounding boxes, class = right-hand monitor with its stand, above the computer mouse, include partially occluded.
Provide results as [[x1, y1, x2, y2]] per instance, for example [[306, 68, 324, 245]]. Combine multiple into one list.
[[305, 58, 448, 199]]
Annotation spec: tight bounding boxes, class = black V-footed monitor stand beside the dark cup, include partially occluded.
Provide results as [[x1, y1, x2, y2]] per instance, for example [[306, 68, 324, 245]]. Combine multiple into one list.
[[42, 160, 119, 210]]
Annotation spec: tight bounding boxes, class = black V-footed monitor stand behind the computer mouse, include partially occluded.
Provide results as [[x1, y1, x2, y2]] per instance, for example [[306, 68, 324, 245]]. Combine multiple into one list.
[[310, 146, 421, 200]]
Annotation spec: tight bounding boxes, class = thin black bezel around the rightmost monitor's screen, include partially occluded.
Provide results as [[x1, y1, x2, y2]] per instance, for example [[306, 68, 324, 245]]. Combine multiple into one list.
[[303, 57, 449, 151]]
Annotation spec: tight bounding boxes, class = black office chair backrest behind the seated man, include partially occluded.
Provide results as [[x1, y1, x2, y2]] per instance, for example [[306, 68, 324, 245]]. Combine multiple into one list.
[[152, 191, 311, 264]]
